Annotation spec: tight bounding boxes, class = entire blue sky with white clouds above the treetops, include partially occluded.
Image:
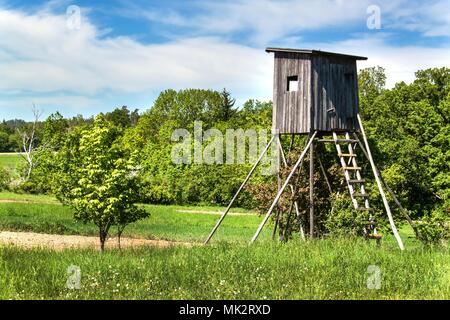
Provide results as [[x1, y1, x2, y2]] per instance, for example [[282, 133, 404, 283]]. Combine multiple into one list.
[[0, 0, 450, 119]]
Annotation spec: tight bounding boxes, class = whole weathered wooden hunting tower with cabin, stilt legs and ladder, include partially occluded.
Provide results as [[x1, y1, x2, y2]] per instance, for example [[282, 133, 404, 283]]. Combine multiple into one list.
[[205, 48, 417, 250]]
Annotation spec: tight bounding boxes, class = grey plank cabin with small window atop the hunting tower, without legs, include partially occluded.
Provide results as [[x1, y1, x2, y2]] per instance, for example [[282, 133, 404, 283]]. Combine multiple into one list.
[[266, 48, 367, 134]]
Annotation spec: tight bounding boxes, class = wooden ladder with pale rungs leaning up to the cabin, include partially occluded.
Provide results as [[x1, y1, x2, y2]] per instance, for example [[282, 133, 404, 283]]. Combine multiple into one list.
[[333, 132, 382, 244]]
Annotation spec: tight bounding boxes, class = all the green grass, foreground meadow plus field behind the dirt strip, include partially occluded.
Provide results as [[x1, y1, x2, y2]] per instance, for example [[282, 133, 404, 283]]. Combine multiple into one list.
[[0, 193, 450, 299]]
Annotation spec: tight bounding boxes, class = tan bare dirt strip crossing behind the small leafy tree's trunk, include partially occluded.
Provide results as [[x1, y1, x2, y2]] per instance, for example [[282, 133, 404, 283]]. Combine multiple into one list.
[[0, 231, 192, 250]]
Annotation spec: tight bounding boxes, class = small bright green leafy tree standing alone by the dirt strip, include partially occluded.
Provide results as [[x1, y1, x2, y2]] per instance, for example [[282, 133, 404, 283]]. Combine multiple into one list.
[[56, 116, 149, 251]]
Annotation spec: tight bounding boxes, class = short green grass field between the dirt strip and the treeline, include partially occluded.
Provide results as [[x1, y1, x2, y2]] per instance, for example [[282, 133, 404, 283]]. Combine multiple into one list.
[[0, 193, 270, 242]]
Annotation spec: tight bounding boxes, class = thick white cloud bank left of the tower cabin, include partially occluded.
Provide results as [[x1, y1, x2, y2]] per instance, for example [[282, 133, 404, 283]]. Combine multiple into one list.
[[0, 10, 270, 95]]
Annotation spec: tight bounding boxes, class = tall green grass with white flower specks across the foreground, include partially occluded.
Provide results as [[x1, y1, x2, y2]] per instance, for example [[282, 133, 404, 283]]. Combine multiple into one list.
[[0, 240, 450, 299]]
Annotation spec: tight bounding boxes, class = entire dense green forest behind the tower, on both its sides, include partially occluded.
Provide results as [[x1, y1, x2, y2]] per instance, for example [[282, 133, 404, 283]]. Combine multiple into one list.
[[0, 67, 450, 241]]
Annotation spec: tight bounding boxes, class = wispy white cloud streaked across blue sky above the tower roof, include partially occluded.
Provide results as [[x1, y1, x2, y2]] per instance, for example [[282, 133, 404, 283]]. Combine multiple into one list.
[[133, 0, 450, 46]]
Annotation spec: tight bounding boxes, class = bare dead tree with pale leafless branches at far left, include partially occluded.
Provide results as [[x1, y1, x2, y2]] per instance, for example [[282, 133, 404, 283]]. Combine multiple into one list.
[[17, 104, 43, 180]]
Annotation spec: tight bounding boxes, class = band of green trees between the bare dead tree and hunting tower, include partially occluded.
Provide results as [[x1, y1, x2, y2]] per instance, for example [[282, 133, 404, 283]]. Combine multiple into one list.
[[20, 89, 272, 205]]
